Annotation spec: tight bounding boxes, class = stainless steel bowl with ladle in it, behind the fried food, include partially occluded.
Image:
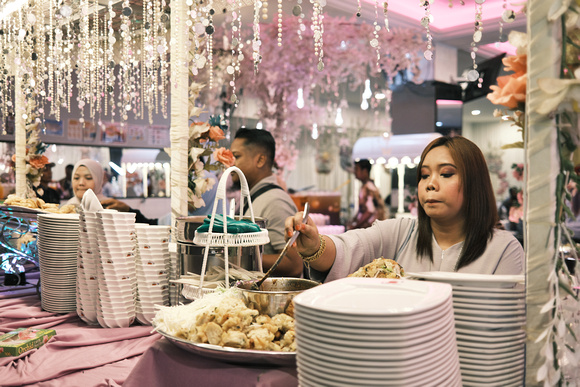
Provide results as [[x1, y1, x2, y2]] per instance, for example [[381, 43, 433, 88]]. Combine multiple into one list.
[[235, 277, 319, 317]]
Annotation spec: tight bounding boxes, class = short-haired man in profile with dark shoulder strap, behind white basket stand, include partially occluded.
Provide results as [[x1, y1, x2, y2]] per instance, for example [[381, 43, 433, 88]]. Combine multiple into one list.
[[230, 129, 302, 277]]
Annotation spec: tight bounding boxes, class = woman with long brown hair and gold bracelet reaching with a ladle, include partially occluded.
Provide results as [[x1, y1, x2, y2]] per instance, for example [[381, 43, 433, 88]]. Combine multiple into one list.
[[285, 137, 524, 281]]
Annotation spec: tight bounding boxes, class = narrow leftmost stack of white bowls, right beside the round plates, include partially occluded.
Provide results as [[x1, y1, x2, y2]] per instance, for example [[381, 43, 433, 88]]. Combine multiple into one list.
[[77, 209, 100, 325]]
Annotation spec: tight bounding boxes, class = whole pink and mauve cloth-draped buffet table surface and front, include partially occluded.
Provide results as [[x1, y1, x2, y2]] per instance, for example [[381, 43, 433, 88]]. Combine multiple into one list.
[[0, 295, 298, 387]]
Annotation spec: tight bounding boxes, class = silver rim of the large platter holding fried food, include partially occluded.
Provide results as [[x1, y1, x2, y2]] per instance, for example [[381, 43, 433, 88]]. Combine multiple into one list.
[[157, 331, 296, 367]]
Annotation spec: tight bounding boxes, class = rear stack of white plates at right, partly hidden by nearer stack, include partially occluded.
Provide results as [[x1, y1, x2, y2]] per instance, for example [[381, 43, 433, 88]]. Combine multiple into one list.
[[409, 272, 526, 387]]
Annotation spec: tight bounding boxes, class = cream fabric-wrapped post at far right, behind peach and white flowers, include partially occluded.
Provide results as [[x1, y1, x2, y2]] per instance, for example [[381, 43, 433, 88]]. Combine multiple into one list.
[[524, 0, 560, 386]]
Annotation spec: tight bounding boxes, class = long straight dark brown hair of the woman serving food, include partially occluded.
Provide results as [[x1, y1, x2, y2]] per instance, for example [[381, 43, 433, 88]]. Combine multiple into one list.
[[417, 136, 498, 270]]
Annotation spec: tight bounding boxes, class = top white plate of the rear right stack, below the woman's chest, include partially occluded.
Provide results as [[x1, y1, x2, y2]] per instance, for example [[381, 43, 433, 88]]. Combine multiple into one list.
[[405, 271, 525, 288]]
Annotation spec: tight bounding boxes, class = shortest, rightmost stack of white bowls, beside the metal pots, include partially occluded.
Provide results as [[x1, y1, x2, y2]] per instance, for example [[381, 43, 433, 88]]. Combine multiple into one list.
[[135, 224, 171, 324]]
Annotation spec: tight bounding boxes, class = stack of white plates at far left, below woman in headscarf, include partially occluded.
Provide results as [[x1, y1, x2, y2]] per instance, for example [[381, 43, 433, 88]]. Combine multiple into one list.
[[37, 214, 79, 313]]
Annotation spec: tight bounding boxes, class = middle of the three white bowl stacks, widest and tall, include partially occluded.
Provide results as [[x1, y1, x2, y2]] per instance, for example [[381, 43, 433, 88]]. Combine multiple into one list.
[[96, 210, 137, 328]]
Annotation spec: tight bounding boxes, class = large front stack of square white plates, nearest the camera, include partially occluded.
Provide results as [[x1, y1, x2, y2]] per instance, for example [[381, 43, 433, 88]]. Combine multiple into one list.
[[294, 278, 461, 387]]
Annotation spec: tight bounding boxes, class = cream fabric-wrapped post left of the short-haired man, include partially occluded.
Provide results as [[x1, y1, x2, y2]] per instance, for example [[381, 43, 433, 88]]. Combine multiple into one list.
[[170, 0, 189, 235]]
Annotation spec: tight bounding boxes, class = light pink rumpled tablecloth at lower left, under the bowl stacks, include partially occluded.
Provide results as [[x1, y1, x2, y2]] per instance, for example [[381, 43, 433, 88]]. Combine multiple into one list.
[[0, 295, 161, 387]]
